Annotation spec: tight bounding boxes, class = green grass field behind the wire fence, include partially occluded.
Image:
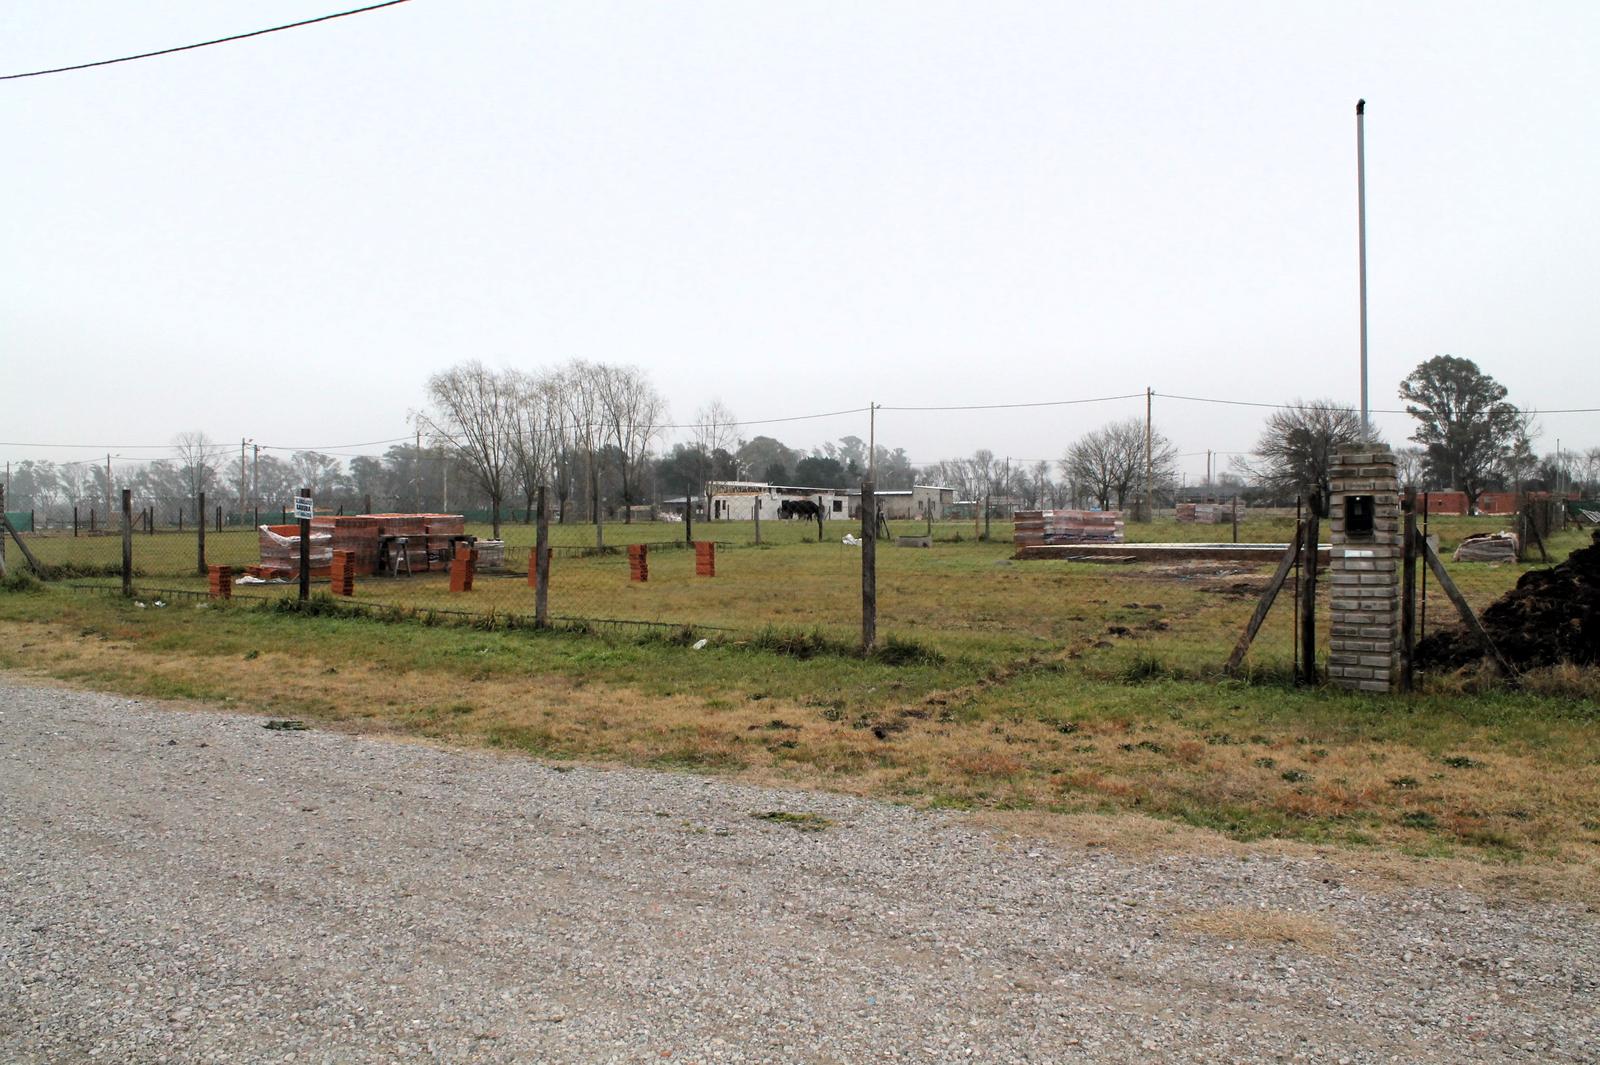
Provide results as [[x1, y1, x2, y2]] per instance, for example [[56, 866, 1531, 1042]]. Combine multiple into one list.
[[12, 518, 1586, 676]]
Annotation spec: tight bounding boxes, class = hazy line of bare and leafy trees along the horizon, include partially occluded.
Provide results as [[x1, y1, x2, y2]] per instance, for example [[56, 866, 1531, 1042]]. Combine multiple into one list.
[[6, 355, 1600, 521]]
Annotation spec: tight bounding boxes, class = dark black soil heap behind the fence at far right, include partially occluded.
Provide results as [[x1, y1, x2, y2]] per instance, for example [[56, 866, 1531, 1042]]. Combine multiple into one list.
[[1416, 533, 1600, 670]]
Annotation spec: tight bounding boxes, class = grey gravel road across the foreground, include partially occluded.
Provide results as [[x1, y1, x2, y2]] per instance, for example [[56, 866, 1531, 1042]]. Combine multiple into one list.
[[0, 681, 1600, 1063]]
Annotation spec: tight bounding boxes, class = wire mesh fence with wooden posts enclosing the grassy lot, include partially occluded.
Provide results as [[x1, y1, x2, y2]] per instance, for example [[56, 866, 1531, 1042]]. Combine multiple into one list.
[[0, 482, 1590, 676]]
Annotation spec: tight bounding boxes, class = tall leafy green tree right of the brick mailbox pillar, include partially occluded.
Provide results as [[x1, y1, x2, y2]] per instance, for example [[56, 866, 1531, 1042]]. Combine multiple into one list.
[[1400, 355, 1528, 509]]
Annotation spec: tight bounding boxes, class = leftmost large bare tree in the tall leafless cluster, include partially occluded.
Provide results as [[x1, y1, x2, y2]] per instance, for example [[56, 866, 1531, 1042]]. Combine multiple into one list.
[[418, 360, 517, 539]]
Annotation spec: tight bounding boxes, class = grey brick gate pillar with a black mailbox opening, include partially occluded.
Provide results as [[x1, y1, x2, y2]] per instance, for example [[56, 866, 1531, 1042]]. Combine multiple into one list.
[[1328, 451, 1402, 691]]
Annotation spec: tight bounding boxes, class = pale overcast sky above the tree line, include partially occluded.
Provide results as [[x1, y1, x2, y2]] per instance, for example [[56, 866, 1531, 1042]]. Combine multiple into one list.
[[0, 0, 1600, 480]]
